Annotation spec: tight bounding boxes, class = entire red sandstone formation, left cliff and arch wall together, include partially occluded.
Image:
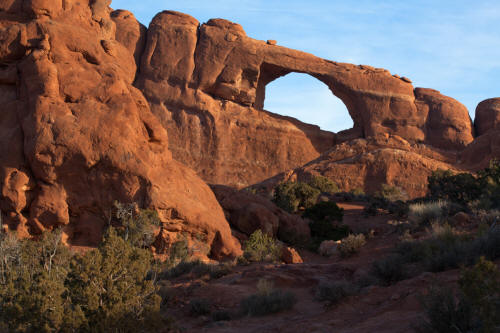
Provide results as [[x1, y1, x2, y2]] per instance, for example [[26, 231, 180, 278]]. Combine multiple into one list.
[[0, 0, 500, 253]]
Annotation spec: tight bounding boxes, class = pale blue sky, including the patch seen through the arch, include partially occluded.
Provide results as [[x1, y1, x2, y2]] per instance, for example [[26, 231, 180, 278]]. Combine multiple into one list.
[[111, 0, 500, 131]]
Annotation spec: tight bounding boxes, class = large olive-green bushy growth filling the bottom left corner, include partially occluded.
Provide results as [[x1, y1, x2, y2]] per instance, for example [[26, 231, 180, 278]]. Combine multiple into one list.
[[0, 227, 162, 332]]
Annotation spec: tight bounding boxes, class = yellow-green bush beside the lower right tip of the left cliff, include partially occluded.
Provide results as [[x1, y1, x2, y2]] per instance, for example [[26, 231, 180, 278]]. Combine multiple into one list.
[[243, 229, 281, 262]]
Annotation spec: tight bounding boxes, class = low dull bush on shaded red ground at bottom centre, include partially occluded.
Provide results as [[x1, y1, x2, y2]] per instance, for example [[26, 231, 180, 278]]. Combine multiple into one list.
[[240, 280, 297, 316]]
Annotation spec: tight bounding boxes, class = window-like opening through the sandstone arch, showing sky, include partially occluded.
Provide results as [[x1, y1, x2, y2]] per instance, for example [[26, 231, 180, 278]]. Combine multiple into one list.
[[255, 65, 354, 133]]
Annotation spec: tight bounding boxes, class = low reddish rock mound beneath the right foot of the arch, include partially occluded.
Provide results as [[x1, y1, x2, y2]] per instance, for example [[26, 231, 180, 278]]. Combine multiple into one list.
[[253, 136, 461, 198]]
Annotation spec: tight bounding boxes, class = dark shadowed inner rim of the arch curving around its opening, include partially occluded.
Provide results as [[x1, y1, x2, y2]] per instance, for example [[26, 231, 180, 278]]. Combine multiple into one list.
[[253, 63, 362, 136]]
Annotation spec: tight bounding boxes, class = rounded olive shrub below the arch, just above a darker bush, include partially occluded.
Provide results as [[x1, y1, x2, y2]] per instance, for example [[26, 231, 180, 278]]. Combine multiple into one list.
[[273, 181, 321, 213]]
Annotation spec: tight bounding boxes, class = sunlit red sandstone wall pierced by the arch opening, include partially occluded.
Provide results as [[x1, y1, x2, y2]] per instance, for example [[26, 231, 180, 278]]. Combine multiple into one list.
[[135, 11, 480, 186]]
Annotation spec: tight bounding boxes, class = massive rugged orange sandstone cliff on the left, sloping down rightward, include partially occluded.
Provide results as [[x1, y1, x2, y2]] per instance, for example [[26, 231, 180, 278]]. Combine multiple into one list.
[[0, 0, 240, 257]]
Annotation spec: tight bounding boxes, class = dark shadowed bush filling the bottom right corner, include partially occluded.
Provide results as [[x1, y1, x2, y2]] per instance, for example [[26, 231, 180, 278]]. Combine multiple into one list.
[[418, 257, 500, 332]]
